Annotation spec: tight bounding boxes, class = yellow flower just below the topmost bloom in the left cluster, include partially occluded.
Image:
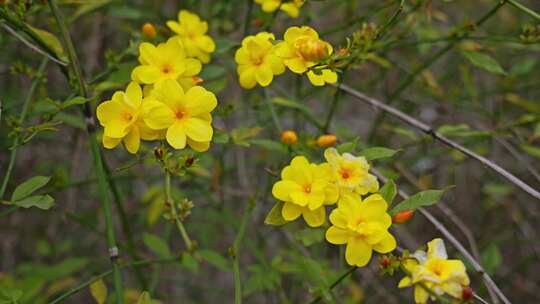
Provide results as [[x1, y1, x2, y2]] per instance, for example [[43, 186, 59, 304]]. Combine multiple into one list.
[[131, 38, 201, 88]]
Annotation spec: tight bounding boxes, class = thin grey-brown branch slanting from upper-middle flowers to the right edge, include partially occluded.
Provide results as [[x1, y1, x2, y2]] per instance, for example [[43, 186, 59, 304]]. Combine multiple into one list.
[[339, 84, 540, 200]]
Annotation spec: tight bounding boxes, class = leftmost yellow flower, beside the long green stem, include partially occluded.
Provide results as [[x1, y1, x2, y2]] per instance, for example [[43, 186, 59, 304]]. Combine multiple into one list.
[[96, 82, 160, 153]]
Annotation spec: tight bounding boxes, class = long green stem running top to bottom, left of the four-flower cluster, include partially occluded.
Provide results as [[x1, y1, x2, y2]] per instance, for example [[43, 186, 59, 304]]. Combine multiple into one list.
[[49, 0, 124, 304]]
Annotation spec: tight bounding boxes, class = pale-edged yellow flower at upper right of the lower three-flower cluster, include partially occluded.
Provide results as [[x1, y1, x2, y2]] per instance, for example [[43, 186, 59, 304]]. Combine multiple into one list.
[[324, 148, 379, 195]]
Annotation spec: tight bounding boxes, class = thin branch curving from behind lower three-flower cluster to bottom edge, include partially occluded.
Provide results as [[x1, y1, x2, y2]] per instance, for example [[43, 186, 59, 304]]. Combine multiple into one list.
[[371, 169, 511, 304]]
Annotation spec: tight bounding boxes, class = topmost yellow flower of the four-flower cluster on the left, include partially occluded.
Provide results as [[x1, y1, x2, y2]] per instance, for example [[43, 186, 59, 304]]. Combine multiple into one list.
[[167, 10, 216, 63]]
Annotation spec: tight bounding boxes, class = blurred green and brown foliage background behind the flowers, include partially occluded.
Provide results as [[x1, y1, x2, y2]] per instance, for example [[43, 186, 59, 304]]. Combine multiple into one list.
[[0, 0, 540, 304]]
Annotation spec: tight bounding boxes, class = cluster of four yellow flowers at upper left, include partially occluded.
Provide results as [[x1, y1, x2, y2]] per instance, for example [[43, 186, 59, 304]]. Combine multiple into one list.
[[97, 11, 217, 153]]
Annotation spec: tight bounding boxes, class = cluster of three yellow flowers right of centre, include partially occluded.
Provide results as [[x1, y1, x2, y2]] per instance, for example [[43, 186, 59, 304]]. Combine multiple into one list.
[[272, 148, 396, 267]]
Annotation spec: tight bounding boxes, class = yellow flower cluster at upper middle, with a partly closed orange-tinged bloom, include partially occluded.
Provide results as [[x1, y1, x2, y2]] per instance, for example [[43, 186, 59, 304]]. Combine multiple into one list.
[[235, 26, 338, 89]]
